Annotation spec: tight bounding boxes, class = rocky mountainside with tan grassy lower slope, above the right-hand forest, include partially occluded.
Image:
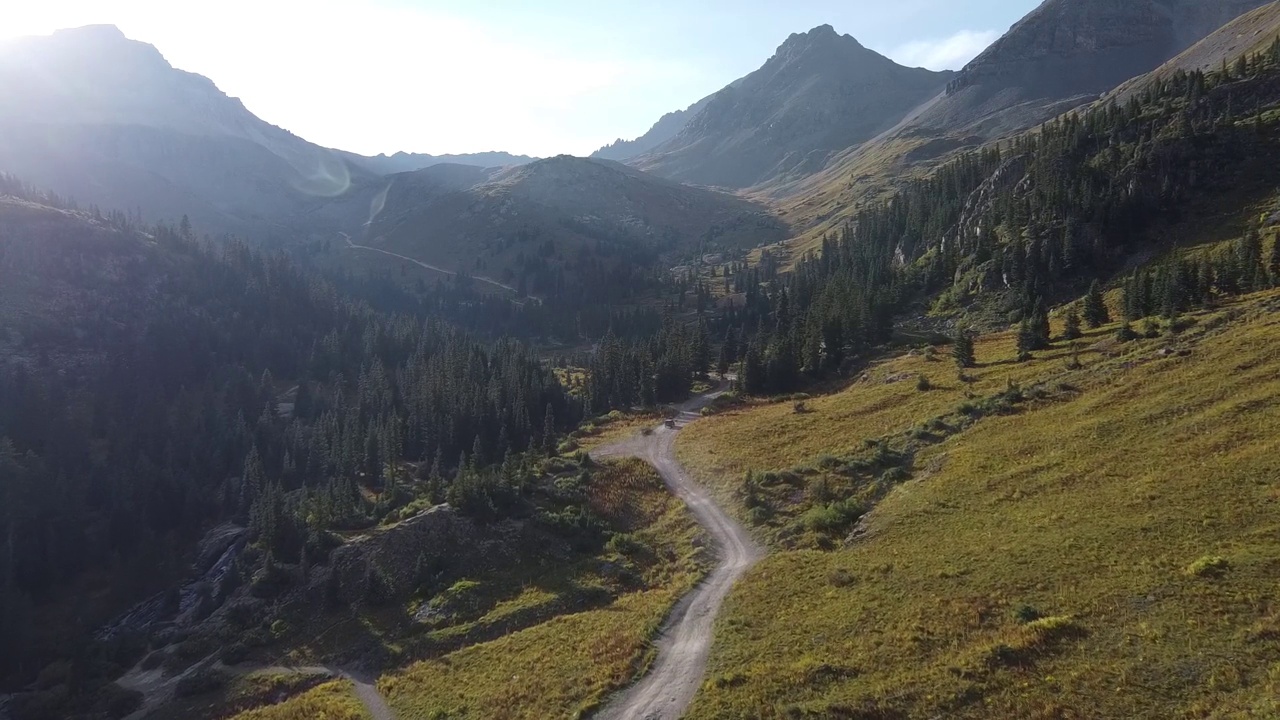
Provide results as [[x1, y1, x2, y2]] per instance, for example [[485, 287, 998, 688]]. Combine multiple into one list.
[[758, 0, 1265, 250]]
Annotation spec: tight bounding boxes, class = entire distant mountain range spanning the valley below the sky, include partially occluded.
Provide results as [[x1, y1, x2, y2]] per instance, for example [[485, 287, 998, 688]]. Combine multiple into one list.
[[0, 0, 1266, 272]]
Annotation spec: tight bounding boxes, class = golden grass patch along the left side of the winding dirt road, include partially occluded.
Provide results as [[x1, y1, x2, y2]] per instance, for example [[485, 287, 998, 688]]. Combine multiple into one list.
[[379, 460, 704, 720]]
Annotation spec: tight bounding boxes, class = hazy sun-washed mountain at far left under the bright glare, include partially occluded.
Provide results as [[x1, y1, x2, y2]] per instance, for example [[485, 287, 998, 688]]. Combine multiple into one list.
[[0, 26, 374, 236]]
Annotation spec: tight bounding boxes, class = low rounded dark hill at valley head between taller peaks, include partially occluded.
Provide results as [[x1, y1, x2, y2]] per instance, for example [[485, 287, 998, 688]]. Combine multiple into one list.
[[362, 156, 787, 301]]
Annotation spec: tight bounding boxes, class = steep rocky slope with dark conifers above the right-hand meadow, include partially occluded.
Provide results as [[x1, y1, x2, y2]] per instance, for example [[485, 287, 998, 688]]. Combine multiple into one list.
[[737, 33, 1280, 392]]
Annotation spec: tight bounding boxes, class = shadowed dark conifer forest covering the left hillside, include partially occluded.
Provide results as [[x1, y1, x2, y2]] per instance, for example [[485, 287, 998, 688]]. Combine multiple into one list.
[[0, 178, 581, 675]]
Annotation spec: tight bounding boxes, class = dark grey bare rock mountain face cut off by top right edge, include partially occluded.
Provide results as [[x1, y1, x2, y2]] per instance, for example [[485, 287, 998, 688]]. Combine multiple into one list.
[[915, 0, 1267, 137]]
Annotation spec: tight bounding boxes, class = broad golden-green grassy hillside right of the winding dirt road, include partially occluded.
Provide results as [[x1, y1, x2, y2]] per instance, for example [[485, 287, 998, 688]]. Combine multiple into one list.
[[678, 288, 1280, 719]]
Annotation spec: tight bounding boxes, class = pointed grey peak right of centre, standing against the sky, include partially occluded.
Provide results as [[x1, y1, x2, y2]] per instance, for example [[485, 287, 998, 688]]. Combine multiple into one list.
[[631, 26, 954, 188]]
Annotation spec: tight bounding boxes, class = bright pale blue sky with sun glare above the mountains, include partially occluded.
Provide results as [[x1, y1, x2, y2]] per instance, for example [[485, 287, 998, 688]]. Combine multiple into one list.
[[0, 0, 1039, 156]]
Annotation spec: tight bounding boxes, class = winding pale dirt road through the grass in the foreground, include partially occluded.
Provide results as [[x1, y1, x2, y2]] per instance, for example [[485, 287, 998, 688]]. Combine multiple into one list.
[[591, 386, 762, 720]]
